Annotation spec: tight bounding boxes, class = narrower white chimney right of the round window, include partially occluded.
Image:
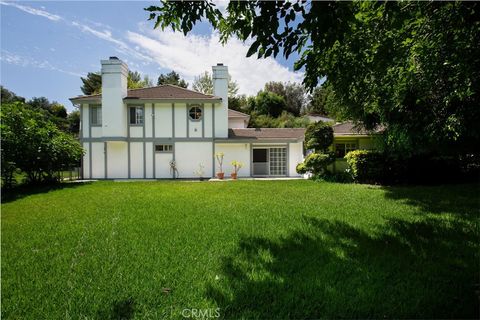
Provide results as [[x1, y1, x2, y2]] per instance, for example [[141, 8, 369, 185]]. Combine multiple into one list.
[[212, 63, 228, 138]]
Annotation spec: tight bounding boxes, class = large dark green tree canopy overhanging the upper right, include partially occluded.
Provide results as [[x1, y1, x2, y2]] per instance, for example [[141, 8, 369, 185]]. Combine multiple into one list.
[[146, 1, 480, 153]]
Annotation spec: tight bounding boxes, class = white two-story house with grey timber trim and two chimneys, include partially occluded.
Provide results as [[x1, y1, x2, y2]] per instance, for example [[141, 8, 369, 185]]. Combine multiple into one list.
[[70, 57, 304, 179]]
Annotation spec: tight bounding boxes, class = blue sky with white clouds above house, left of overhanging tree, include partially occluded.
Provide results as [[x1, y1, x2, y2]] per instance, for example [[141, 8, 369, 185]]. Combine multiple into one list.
[[0, 1, 302, 110]]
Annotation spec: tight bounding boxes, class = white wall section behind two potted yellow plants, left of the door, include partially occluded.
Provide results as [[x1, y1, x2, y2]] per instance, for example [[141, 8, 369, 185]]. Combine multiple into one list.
[[215, 143, 250, 178]]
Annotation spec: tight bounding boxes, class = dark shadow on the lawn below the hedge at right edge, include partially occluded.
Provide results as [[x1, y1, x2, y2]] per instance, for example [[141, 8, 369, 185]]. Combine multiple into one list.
[[383, 184, 480, 219]]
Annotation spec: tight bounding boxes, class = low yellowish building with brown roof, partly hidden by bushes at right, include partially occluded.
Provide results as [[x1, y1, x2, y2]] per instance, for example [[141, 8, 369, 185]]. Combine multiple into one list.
[[331, 121, 382, 172]]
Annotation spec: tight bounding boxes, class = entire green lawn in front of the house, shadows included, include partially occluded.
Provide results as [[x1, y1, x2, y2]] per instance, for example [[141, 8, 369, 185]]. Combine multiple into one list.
[[1, 181, 480, 319]]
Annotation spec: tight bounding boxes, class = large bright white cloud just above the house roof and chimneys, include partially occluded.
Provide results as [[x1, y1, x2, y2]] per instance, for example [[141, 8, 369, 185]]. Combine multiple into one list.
[[127, 30, 303, 94]]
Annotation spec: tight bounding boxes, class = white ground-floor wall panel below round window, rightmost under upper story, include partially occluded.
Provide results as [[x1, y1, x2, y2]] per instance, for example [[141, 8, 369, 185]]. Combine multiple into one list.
[[174, 142, 213, 178]]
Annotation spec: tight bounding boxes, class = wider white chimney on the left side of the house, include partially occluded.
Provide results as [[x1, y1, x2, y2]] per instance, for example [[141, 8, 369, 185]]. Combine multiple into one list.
[[101, 57, 128, 137]]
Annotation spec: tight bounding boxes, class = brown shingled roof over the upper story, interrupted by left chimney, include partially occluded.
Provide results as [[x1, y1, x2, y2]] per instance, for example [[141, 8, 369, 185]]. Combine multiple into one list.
[[70, 84, 221, 101]]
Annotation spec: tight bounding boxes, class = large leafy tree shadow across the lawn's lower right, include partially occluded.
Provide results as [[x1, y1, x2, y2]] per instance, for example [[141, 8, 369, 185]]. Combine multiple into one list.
[[207, 217, 479, 319]]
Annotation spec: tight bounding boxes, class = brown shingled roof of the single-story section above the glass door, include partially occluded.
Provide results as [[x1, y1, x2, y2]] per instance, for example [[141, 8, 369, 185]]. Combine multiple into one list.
[[228, 128, 305, 140]]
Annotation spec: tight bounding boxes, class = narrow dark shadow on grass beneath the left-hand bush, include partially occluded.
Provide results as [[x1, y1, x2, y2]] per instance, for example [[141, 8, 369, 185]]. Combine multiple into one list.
[[2, 182, 91, 203]]
